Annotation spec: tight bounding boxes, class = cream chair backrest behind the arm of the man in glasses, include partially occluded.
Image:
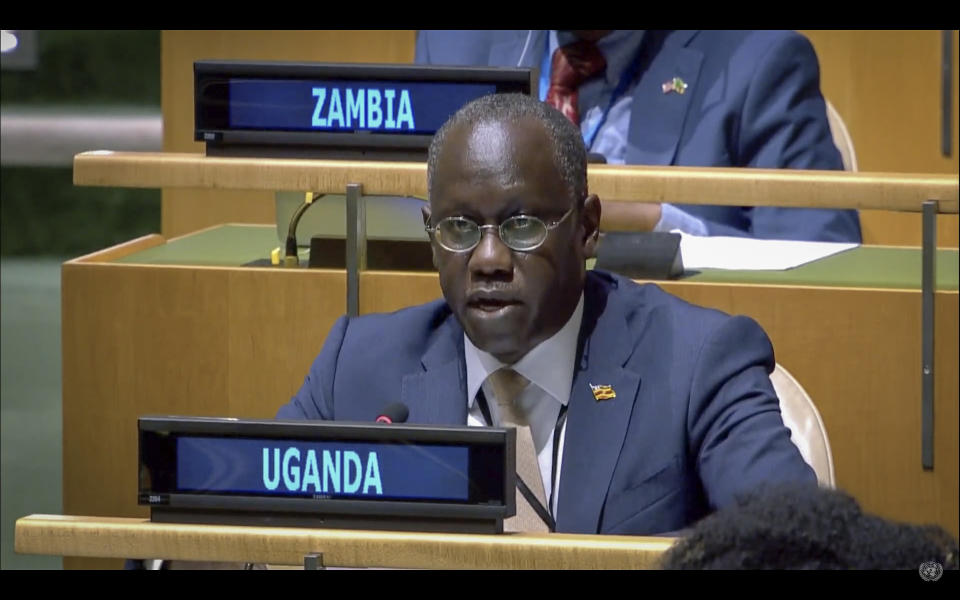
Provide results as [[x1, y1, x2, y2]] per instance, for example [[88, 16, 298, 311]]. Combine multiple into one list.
[[770, 364, 836, 488]]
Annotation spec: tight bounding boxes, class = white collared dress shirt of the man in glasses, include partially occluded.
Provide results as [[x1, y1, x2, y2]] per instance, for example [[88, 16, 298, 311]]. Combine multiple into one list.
[[463, 293, 583, 515]]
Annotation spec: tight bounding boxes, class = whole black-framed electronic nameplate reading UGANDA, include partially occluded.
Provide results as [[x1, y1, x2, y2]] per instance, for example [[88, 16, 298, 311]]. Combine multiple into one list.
[[137, 416, 515, 533]]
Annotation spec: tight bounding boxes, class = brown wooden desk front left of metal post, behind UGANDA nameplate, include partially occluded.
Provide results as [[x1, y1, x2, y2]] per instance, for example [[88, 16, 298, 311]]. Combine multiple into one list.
[[61, 255, 346, 568]]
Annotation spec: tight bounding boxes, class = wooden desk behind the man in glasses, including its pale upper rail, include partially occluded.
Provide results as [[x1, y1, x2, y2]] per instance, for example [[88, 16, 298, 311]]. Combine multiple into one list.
[[61, 152, 960, 566]]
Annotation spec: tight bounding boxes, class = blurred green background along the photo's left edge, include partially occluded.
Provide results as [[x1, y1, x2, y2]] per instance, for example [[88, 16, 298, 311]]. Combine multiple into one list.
[[0, 30, 160, 569]]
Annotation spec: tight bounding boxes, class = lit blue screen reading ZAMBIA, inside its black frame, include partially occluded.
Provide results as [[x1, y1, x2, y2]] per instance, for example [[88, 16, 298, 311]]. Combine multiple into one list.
[[229, 79, 496, 135]]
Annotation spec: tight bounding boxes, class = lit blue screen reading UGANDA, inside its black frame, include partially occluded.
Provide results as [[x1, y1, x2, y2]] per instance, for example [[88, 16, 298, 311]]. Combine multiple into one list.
[[177, 437, 469, 501]]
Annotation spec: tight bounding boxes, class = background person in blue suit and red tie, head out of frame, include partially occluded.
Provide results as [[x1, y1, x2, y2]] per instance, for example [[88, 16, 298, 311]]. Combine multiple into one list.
[[416, 30, 861, 242]]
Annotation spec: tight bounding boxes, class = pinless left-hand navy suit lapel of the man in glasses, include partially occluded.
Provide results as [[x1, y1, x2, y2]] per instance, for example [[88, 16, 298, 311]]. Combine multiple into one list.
[[400, 315, 467, 425]]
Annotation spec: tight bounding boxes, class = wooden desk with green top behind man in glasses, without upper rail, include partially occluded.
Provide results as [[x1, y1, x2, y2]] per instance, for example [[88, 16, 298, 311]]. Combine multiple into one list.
[[61, 226, 960, 567]]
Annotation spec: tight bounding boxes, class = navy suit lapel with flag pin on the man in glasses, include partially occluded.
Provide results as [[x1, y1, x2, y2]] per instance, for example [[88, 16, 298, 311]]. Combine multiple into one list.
[[557, 276, 640, 533]]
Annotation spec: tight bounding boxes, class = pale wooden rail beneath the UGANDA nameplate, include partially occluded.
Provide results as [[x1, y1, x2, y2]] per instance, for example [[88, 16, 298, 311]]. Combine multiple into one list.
[[15, 515, 674, 569]]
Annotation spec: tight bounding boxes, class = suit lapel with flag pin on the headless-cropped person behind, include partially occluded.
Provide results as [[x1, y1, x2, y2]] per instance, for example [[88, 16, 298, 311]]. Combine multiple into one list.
[[626, 31, 703, 165]]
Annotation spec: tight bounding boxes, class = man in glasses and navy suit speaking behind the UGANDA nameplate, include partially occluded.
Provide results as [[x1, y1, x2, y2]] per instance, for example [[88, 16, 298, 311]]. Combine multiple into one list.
[[277, 95, 816, 534]]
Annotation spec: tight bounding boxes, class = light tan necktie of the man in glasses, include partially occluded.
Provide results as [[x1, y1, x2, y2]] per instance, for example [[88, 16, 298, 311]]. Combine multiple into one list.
[[488, 368, 549, 532]]
